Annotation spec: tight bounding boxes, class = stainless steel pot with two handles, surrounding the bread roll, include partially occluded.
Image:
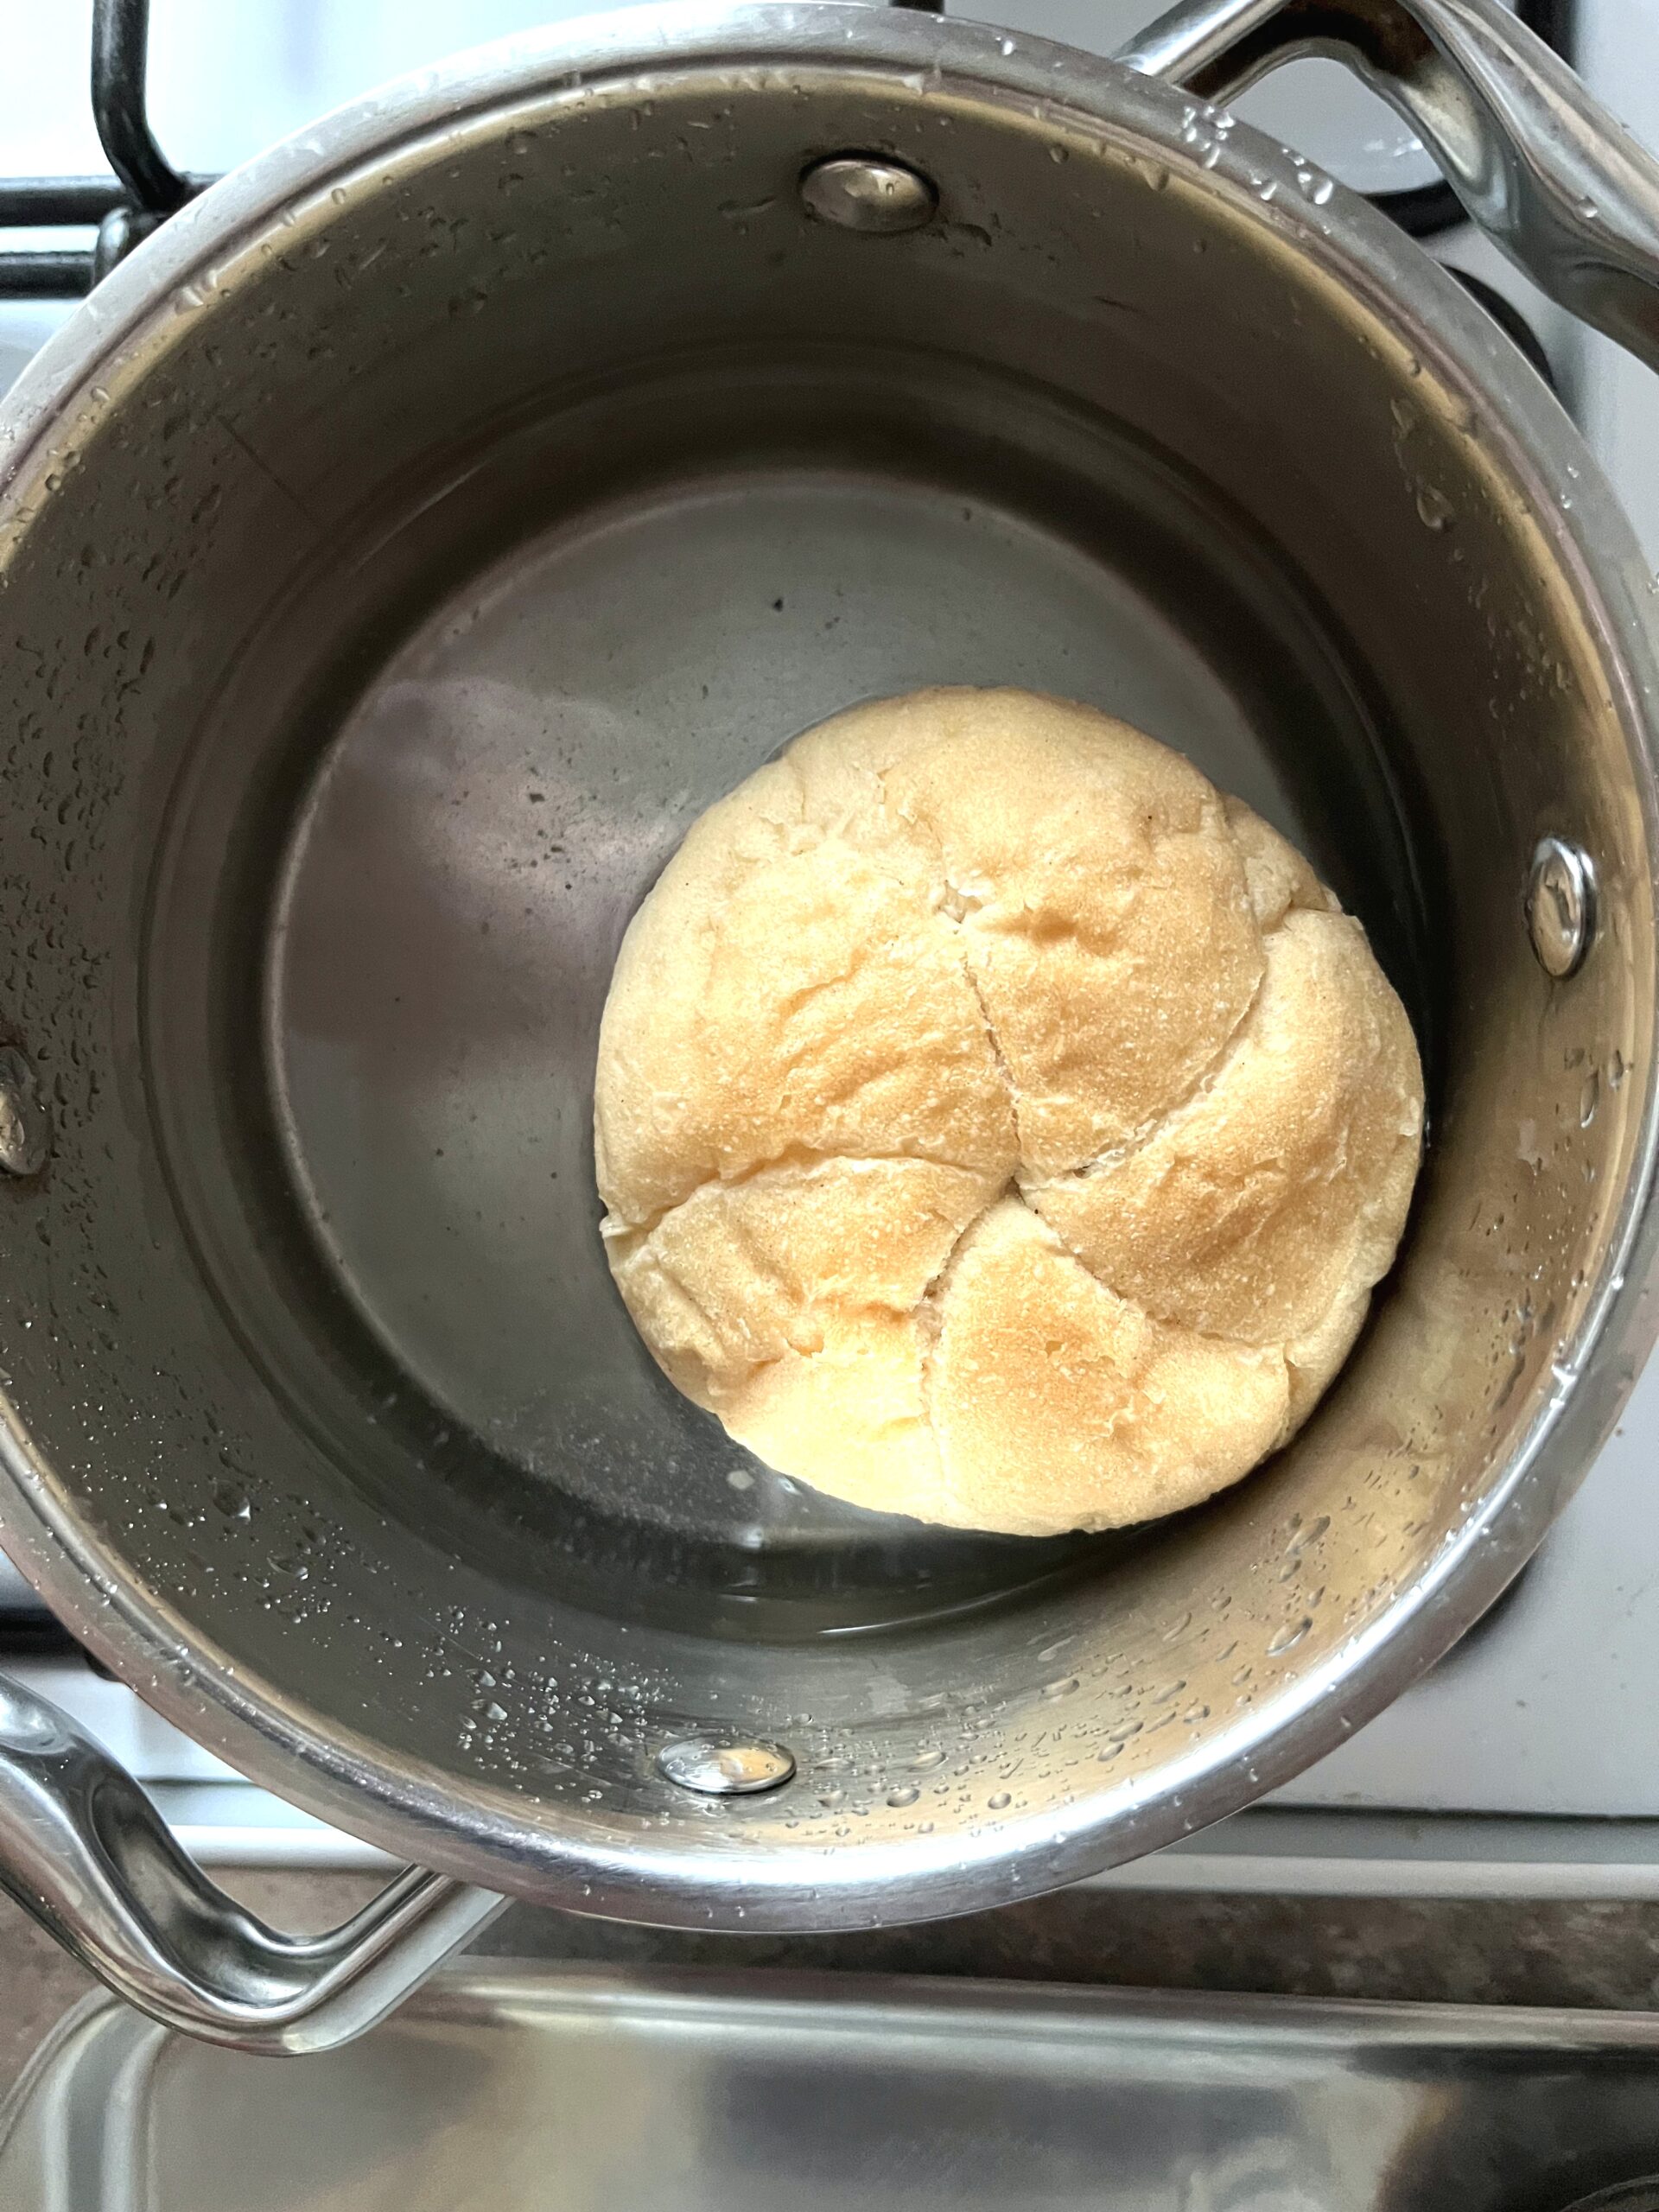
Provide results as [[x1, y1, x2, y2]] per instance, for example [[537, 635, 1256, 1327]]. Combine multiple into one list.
[[0, 0, 1659, 2049]]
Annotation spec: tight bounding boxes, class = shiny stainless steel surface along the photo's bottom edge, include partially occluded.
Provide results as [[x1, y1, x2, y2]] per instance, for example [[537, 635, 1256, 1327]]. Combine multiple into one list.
[[0, 1964, 1659, 2212]]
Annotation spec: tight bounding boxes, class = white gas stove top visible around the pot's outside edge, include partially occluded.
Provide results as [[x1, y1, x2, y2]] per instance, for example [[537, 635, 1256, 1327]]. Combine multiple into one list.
[[0, 0, 1659, 1897]]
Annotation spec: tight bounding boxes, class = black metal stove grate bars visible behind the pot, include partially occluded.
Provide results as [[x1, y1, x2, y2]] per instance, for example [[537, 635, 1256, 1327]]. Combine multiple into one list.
[[0, 0, 1577, 299]]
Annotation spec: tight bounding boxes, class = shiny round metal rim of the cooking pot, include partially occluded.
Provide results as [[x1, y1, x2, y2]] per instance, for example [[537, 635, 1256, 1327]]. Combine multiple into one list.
[[0, 0, 1659, 1931]]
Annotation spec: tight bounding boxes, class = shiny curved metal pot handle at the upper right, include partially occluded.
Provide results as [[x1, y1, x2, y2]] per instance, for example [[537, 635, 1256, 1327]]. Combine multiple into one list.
[[1117, 0, 1659, 370]]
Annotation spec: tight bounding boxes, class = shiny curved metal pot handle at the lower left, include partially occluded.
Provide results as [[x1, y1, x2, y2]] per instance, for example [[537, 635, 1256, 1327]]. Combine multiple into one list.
[[0, 1675, 506, 2050]]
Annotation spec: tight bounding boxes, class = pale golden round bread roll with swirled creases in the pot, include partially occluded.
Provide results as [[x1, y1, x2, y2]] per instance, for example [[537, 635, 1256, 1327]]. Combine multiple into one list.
[[595, 690, 1422, 1535]]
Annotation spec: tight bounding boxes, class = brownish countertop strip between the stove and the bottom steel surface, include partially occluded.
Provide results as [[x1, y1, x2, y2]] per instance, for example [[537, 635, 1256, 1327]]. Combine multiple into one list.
[[0, 1869, 1659, 2093]]
